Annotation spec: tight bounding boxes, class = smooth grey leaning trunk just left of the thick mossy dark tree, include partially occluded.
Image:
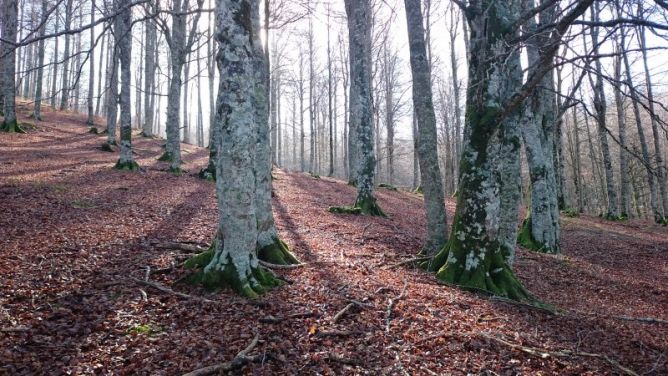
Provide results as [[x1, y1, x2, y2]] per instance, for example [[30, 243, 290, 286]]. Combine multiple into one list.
[[402, 0, 448, 255]]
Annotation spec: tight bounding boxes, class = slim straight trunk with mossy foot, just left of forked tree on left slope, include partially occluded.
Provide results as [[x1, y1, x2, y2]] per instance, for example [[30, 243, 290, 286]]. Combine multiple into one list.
[[114, 0, 139, 170]]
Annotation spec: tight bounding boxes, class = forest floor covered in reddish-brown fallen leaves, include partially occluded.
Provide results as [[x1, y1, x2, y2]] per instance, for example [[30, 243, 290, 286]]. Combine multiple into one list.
[[0, 104, 668, 375]]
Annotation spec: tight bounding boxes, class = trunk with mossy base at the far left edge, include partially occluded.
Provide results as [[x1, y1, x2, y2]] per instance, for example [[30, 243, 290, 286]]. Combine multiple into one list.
[[0, 0, 22, 133]]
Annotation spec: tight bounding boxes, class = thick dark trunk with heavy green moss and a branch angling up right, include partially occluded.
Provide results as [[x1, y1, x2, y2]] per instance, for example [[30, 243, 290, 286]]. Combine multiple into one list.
[[428, 0, 593, 300]]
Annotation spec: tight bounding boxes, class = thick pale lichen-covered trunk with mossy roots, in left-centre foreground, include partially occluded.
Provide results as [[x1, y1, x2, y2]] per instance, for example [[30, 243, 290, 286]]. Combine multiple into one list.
[[198, 0, 284, 298]]
